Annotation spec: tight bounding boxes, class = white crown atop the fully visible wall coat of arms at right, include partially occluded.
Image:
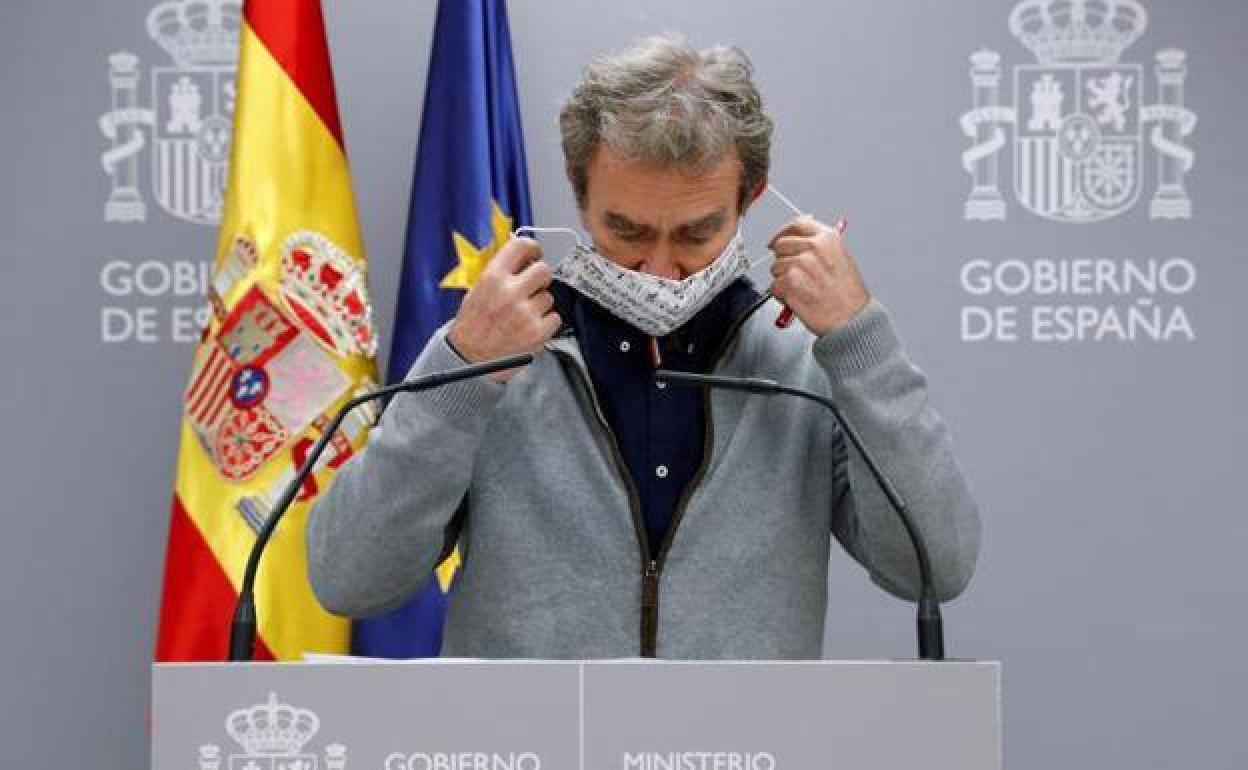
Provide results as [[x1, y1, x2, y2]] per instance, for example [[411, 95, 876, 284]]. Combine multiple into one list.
[[1010, 0, 1148, 64]]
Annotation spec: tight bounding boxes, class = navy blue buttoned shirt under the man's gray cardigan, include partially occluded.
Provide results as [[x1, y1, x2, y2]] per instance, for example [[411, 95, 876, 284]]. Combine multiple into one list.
[[559, 278, 760, 557]]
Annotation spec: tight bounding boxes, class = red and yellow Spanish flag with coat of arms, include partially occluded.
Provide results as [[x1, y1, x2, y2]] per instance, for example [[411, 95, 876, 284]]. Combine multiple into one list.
[[156, 0, 377, 660]]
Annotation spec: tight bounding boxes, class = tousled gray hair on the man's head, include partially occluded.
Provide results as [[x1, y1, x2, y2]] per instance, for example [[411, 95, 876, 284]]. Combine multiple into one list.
[[559, 35, 773, 208]]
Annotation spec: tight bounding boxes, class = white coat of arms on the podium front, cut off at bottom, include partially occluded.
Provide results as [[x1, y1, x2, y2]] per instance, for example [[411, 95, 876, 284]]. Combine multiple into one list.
[[198, 693, 347, 770]]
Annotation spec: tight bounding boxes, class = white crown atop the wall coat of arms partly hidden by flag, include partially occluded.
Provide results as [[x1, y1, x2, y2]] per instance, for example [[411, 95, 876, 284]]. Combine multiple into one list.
[[147, 0, 242, 69]]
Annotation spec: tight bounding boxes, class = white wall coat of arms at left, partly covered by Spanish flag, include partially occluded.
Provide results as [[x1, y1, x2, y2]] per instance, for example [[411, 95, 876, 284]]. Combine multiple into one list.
[[100, 0, 242, 225]]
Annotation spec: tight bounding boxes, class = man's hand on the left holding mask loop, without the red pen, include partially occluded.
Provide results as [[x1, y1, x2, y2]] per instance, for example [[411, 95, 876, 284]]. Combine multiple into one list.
[[447, 237, 560, 382]]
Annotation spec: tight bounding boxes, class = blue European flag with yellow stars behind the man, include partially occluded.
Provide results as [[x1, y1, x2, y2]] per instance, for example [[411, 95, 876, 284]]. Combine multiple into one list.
[[352, 0, 533, 658]]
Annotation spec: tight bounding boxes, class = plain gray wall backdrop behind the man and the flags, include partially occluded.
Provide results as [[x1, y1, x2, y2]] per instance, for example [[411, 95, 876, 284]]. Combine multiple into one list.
[[0, 0, 1248, 770]]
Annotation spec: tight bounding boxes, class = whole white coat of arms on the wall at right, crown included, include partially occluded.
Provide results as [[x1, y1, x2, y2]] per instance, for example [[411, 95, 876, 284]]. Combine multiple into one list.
[[961, 0, 1196, 222]]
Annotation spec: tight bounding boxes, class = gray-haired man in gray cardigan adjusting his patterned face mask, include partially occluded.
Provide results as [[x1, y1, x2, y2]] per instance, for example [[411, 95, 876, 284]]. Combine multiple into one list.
[[308, 37, 980, 659]]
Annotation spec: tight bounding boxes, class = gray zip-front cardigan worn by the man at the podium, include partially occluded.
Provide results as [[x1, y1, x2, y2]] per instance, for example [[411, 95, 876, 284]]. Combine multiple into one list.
[[307, 300, 980, 659]]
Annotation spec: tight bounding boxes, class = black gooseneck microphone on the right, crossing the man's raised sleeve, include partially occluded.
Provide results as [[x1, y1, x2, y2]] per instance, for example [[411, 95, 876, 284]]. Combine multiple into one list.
[[654, 369, 945, 660]]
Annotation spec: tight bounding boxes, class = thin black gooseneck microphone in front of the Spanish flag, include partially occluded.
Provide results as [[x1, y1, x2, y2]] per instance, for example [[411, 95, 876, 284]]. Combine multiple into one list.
[[228, 353, 533, 661]]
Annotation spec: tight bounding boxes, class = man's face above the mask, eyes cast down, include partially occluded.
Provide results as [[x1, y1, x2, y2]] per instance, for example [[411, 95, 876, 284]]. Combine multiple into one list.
[[580, 146, 741, 280]]
